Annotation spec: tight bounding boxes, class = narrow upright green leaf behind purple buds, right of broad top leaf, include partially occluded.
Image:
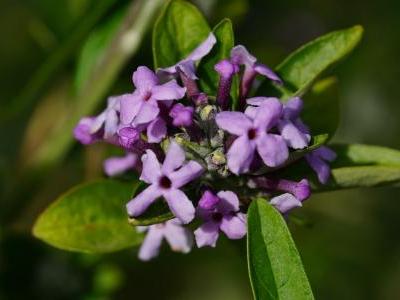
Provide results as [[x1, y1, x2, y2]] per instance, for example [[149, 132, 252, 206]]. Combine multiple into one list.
[[198, 19, 239, 103]]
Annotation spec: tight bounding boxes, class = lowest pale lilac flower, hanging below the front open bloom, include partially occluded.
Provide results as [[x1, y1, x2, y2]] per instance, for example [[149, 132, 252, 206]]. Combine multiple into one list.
[[138, 219, 193, 261]]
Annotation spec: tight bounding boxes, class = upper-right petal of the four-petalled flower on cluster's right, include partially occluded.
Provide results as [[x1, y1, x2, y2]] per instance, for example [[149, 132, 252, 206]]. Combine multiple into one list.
[[254, 97, 283, 130]]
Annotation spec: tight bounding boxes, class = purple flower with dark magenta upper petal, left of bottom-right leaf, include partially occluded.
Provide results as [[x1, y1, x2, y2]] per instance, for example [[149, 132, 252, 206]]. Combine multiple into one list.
[[194, 191, 246, 248]]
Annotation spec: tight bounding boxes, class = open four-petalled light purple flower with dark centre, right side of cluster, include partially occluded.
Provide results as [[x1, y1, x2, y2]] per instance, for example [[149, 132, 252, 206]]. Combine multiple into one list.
[[215, 98, 289, 174]]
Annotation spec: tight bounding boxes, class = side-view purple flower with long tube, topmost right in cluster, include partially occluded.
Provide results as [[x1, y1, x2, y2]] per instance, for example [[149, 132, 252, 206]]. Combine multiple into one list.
[[231, 45, 282, 105]]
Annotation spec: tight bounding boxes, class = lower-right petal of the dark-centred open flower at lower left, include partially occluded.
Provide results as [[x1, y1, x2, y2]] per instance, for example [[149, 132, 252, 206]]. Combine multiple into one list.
[[164, 189, 195, 224]]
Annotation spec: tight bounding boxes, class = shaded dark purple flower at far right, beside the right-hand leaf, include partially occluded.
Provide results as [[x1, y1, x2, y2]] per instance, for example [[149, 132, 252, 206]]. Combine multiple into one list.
[[306, 146, 336, 184]]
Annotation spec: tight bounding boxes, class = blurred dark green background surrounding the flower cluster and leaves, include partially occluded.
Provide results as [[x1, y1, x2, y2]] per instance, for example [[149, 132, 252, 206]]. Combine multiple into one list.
[[0, 0, 400, 300]]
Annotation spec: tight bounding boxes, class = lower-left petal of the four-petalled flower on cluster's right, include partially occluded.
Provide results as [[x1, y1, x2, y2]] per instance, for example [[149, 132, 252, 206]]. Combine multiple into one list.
[[226, 136, 255, 175]]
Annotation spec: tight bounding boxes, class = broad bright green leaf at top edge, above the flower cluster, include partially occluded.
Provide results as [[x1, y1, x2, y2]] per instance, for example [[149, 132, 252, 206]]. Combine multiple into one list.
[[153, 0, 210, 69]]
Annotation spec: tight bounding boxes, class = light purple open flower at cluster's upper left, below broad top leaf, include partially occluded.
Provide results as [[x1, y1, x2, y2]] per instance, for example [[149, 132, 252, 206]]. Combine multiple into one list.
[[121, 66, 186, 127]]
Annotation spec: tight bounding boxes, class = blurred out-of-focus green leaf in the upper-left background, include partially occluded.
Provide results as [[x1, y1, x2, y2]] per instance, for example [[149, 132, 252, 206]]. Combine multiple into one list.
[[75, 7, 127, 91]]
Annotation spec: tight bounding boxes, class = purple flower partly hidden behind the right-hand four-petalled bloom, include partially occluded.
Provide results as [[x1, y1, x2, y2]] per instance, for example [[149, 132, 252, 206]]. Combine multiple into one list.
[[246, 97, 311, 149]]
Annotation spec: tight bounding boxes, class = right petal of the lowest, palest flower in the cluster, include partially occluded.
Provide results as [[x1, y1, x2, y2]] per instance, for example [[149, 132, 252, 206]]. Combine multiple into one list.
[[164, 220, 193, 253]]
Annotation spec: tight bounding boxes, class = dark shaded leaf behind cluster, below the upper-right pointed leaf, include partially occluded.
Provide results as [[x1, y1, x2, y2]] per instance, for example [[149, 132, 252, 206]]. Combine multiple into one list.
[[301, 77, 340, 138]]
